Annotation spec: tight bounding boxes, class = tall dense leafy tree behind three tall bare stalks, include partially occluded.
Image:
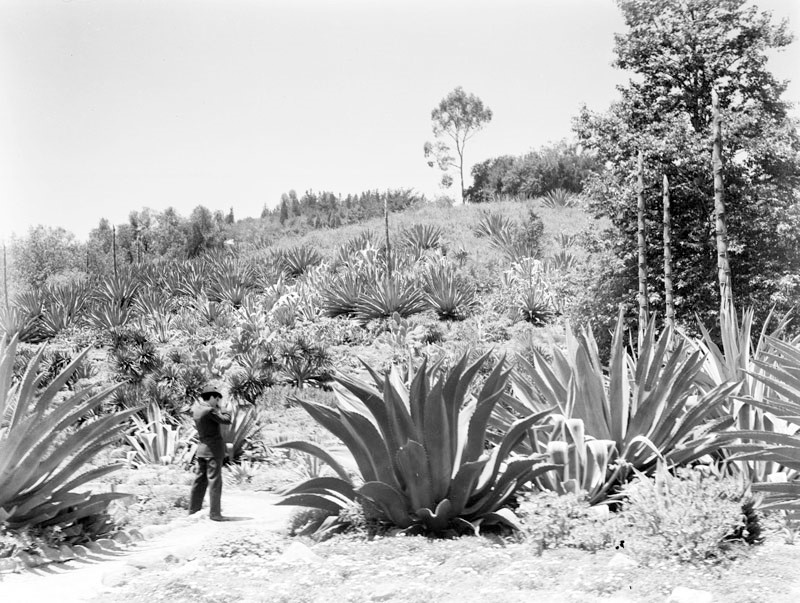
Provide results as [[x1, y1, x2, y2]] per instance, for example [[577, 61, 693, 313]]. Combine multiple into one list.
[[574, 0, 800, 340]]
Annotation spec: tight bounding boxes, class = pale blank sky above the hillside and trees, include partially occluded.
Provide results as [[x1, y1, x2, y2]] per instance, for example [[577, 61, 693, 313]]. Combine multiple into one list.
[[0, 0, 800, 239]]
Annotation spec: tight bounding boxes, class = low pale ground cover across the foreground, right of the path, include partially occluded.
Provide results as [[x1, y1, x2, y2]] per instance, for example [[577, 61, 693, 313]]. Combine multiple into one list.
[[90, 527, 800, 603]]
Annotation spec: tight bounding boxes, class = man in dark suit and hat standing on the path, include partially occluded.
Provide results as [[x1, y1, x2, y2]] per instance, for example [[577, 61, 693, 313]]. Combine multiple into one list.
[[189, 385, 231, 521]]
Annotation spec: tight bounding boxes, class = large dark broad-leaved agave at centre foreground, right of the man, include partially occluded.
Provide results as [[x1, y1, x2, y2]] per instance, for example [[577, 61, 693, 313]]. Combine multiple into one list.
[[280, 354, 553, 535]]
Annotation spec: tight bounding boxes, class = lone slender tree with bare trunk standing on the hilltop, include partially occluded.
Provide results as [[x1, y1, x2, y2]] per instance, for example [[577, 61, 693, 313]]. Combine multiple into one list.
[[424, 86, 492, 201]]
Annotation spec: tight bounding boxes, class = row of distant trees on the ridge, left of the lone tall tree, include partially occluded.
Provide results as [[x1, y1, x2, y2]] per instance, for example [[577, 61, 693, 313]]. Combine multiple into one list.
[[8, 189, 426, 290]]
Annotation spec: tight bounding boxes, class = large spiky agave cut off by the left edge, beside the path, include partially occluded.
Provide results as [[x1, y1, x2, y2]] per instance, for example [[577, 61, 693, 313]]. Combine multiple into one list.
[[0, 338, 138, 528]]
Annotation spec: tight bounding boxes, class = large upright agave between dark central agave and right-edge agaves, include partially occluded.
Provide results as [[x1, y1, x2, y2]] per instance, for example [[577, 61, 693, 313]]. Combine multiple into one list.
[[506, 312, 738, 486]]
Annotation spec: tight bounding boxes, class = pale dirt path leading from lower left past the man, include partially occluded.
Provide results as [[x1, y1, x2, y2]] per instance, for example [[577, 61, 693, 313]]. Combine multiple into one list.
[[0, 491, 294, 603]]
